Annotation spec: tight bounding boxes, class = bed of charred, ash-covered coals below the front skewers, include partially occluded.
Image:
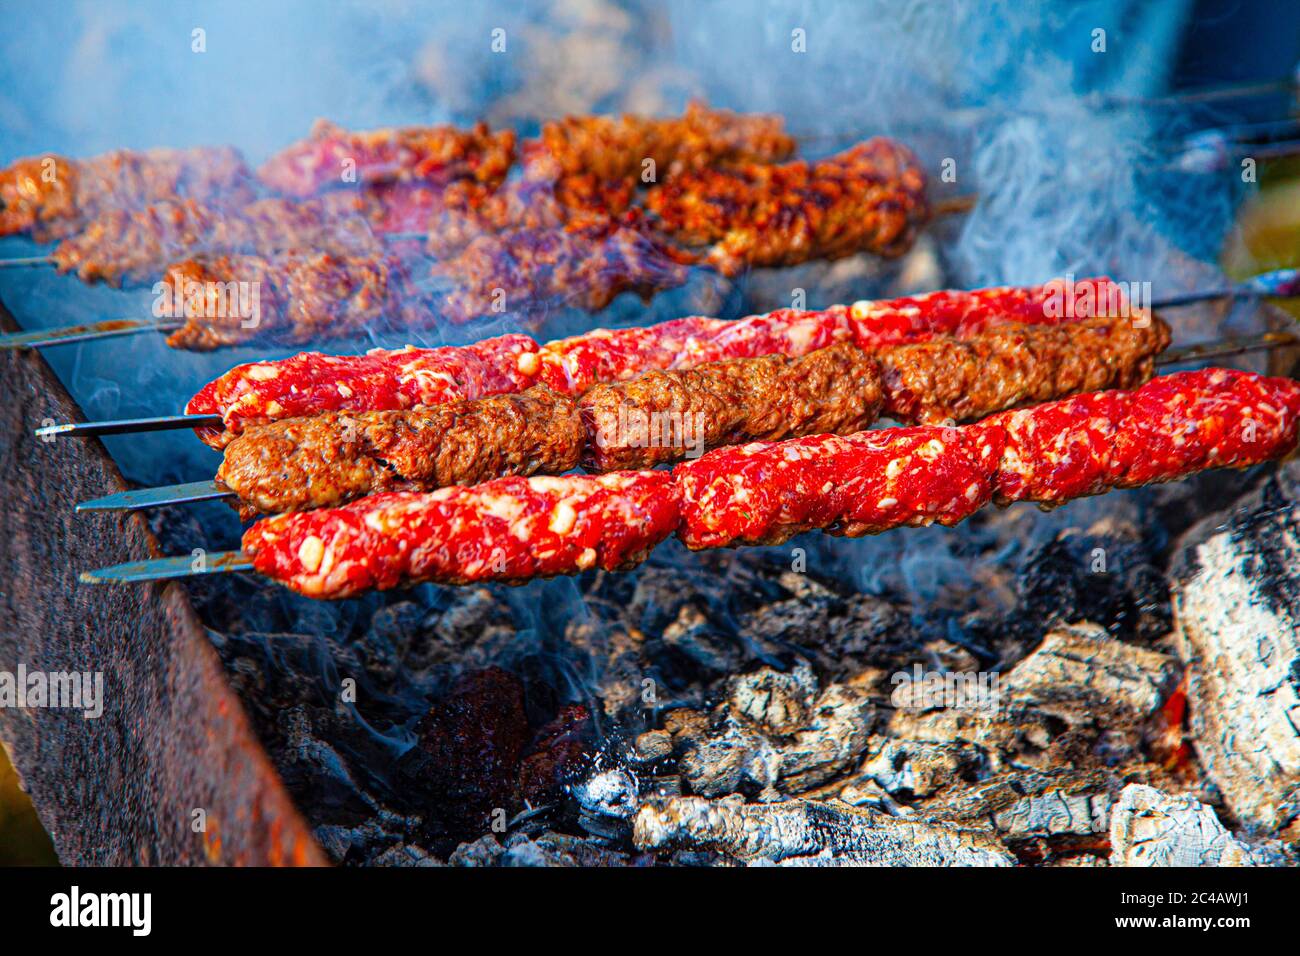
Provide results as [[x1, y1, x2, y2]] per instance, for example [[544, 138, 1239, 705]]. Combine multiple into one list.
[[159, 478, 1289, 865]]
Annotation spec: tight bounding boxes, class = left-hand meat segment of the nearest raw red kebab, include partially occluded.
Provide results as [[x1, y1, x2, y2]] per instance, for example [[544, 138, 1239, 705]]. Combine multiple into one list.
[[243, 471, 679, 598]]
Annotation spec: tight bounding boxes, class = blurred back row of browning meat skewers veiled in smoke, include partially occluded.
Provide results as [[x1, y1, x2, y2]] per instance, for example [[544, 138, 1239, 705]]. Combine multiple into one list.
[[0, 103, 931, 350]]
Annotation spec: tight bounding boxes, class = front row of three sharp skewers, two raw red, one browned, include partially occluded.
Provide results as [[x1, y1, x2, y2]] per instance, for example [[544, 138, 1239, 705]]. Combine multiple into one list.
[[55, 280, 1300, 598]]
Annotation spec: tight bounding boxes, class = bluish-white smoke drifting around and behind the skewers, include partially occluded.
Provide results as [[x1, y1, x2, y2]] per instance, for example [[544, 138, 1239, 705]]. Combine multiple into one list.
[[0, 0, 1274, 723]]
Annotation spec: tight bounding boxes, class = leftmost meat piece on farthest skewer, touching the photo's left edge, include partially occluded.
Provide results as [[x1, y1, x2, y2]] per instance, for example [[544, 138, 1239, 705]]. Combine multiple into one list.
[[0, 147, 252, 242]]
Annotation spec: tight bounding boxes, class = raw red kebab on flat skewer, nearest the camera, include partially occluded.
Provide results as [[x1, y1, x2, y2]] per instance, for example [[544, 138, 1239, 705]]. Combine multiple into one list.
[[82, 368, 1300, 598]]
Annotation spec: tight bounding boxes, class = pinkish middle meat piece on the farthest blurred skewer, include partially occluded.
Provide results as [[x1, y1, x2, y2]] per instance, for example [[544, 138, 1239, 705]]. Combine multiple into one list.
[[257, 120, 515, 196]]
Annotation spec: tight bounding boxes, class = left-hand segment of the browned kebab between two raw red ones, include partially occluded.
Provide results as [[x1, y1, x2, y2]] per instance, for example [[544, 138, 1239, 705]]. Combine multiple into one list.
[[217, 386, 582, 518]]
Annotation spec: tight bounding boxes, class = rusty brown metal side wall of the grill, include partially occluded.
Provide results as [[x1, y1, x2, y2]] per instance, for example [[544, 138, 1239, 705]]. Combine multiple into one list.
[[0, 303, 328, 865]]
